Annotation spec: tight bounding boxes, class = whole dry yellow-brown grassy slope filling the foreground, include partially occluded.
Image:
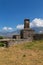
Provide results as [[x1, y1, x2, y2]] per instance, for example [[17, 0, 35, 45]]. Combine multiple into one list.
[[0, 41, 43, 65]]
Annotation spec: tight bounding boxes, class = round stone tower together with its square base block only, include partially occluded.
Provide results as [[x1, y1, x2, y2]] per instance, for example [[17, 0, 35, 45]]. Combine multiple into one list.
[[20, 19, 34, 40]]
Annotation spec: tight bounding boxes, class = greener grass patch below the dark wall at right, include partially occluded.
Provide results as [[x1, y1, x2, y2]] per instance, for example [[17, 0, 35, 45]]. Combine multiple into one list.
[[24, 40, 43, 50]]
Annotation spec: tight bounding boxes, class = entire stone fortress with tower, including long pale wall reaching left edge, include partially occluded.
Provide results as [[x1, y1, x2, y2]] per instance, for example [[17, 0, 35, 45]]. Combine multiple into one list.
[[0, 19, 43, 47]]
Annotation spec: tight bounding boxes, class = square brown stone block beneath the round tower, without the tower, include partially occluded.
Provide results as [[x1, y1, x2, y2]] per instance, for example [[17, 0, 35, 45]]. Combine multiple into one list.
[[20, 28, 34, 39]]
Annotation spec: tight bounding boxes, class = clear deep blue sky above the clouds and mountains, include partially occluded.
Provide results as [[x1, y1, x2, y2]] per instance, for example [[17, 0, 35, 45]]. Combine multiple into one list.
[[0, 0, 43, 30]]
